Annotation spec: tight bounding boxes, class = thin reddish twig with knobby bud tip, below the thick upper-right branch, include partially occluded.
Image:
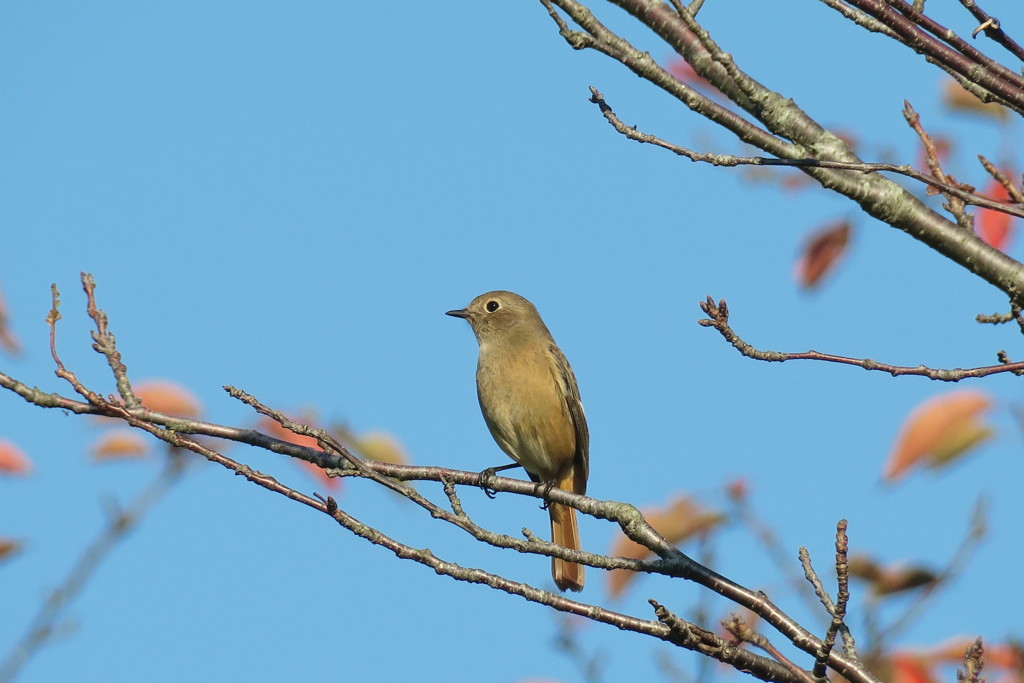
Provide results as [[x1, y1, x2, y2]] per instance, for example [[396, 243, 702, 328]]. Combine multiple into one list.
[[697, 297, 1024, 382]]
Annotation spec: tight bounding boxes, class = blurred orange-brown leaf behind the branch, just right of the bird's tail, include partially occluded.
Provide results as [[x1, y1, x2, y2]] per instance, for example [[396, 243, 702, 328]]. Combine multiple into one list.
[[606, 496, 725, 598]]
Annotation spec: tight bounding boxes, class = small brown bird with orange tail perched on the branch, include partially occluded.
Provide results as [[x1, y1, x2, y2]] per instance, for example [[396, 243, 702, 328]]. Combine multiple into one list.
[[446, 292, 590, 591]]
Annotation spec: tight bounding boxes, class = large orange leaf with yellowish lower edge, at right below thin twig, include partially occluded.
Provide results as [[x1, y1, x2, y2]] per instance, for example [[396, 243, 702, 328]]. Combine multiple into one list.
[[882, 389, 991, 481]]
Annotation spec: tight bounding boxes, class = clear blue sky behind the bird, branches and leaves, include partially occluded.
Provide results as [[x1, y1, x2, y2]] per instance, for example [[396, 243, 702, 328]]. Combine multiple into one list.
[[0, 0, 1024, 681]]
